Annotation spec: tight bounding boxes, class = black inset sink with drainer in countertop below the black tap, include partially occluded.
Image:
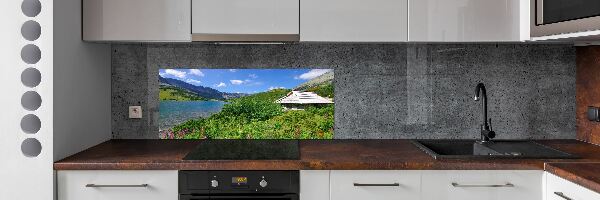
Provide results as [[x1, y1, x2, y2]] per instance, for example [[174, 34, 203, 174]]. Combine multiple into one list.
[[412, 140, 578, 159]]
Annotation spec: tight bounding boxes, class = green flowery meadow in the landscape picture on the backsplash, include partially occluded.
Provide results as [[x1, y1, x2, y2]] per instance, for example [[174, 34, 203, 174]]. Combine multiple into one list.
[[164, 89, 334, 139]]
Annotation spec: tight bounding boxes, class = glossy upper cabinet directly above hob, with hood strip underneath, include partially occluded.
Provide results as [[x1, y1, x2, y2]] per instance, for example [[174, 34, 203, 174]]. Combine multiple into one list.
[[192, 0, 300, 41]]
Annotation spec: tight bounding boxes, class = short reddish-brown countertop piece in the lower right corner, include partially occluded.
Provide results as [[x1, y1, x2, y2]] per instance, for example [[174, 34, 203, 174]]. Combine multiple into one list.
[[545, 162, 600, 193]]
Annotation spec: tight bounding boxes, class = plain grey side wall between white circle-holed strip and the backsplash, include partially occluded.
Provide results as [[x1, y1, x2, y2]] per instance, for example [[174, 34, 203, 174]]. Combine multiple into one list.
[[54, 0, 111, 160]]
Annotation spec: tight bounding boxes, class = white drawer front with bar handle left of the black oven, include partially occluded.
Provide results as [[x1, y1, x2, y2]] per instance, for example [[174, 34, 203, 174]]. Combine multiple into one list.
[[57, 170, 178, 200]]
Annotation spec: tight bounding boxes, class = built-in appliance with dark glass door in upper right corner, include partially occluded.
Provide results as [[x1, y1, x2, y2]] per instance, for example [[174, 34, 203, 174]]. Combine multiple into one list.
[[531, 0, 600, 37]]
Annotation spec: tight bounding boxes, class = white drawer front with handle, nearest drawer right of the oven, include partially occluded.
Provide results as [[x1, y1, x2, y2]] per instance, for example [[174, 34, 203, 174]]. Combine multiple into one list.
[[330, 170, 421, 200]]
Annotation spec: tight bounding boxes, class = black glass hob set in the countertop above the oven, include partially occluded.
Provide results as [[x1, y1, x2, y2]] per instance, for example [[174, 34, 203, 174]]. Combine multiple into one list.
[[183, 140, 300, 160]]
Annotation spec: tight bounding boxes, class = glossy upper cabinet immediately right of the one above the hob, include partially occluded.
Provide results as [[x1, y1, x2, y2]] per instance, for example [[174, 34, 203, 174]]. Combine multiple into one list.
[[300, 0, 408, 42]]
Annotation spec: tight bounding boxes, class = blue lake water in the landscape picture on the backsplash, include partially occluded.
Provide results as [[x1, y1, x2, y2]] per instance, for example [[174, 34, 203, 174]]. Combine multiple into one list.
[[158, 101, 227, 130]]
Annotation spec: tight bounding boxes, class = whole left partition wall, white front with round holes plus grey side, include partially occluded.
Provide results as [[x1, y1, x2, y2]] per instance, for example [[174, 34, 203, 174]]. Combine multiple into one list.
[[0, 0, 111, 200]]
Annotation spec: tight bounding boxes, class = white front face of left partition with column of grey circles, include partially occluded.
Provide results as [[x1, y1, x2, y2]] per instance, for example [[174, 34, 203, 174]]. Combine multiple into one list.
[[0, 0, 53, 200]]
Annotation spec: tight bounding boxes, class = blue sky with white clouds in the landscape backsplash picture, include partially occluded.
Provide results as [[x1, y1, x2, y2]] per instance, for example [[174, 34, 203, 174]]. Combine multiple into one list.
[[159, 69, 332, 94]]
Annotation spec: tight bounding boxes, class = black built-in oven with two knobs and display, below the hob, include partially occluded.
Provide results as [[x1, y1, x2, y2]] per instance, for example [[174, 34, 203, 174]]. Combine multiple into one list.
[[179, 171, 300, 200]]
